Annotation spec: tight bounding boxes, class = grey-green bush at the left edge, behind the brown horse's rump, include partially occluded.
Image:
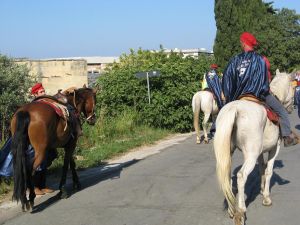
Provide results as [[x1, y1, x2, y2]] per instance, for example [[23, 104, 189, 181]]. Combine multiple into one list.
[[0, 55, 32, 140]]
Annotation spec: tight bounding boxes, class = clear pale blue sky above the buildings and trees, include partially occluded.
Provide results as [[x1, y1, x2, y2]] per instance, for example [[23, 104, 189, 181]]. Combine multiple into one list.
[[0, 0, 300, 59]]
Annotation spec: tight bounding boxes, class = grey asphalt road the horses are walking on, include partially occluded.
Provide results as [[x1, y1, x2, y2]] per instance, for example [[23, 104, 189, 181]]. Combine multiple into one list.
[[0, 113, 300, 225]]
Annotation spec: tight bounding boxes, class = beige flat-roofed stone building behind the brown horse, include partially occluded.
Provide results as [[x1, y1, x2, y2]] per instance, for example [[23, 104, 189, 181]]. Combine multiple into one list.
[[15, 56, 118, 95]]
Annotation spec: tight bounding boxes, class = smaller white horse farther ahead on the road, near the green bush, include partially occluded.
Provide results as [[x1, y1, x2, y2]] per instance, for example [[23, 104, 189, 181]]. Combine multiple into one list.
[[192, 91, 219, 144]]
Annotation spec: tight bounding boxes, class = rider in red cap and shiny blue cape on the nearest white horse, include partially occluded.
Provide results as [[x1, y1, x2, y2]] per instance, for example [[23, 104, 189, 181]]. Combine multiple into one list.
[[222, 32, 298, 147]]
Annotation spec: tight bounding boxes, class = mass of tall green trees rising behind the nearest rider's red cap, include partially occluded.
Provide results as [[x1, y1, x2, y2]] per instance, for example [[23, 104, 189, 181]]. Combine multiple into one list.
[[214, 0, 300, 72]]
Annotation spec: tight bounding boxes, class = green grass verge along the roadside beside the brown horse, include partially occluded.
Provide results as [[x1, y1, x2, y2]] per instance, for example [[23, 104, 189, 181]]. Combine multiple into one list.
[[0, 110, 173, 197]]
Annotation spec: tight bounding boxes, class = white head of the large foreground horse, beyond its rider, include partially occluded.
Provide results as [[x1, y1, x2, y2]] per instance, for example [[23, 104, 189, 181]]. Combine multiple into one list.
[[270, 70, 294, 113]]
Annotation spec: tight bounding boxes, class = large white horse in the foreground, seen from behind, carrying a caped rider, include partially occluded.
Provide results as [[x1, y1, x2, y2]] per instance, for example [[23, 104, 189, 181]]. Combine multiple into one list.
[[214, 72, 293, 225]]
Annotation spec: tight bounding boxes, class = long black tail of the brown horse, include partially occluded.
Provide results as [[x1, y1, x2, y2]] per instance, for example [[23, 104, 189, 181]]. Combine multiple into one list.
[[11, 111, 30, 204]]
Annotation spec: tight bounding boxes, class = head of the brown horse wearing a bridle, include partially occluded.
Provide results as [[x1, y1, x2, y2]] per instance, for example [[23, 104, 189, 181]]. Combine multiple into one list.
[[66, 86, 97, 125]]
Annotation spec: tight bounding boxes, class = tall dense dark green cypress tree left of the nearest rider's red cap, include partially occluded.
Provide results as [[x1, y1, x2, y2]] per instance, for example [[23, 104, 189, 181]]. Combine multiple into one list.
[[214, 0, 268, 68]]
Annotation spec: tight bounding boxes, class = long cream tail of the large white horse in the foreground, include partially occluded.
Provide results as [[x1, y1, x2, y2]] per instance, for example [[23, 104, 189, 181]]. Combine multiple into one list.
[[214, 105, 237, 216]]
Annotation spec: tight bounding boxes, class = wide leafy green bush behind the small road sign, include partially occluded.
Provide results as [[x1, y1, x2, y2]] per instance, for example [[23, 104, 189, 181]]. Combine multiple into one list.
[[98, 49, 214, 132]]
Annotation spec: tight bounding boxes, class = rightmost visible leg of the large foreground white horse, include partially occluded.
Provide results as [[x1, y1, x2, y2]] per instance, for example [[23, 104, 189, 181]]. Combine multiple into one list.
[[262, 140, 280, 206]]
